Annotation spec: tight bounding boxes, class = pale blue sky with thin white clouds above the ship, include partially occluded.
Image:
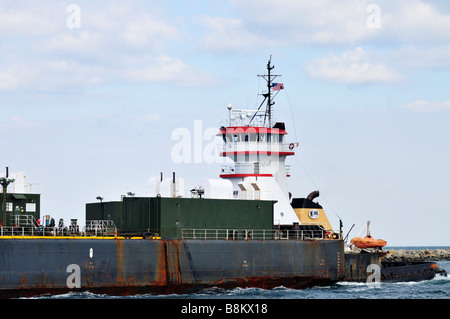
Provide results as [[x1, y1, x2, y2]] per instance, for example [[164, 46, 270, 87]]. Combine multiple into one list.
[[0, 0, 450, 246]]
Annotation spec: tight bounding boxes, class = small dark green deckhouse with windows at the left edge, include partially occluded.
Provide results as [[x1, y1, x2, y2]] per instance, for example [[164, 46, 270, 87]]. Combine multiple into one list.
[[0, 193, 41, 226]]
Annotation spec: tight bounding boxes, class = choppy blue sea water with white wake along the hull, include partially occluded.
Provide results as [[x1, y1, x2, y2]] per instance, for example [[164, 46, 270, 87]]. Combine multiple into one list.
[[30, 261, 450, 300]]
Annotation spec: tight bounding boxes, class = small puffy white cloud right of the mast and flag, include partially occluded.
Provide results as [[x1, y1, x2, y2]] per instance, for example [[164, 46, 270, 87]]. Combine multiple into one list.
[[306, 47, 403, 84]]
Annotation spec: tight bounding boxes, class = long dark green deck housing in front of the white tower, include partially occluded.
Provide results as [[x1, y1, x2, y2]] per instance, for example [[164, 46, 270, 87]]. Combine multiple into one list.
[[86, 197, 275, 238]]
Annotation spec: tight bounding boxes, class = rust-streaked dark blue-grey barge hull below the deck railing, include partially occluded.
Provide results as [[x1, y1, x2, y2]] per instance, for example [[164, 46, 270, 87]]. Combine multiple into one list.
[[0, 238, 344, 298]]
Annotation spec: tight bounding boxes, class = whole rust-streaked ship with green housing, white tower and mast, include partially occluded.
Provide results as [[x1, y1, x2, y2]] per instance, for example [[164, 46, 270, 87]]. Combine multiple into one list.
[[0, 59, 345, 298]]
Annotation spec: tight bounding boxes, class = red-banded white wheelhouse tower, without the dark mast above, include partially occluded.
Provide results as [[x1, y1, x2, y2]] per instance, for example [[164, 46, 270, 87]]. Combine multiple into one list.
[[214, 105, 298, 224]]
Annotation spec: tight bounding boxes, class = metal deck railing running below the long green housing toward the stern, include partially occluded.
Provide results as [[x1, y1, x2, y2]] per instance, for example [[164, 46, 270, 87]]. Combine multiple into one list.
[[181, 229, 341, 240]]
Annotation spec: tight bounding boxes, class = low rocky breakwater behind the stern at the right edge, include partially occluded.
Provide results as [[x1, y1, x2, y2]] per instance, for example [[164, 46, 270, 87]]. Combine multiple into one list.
[[382, 249, 450, 262]]
